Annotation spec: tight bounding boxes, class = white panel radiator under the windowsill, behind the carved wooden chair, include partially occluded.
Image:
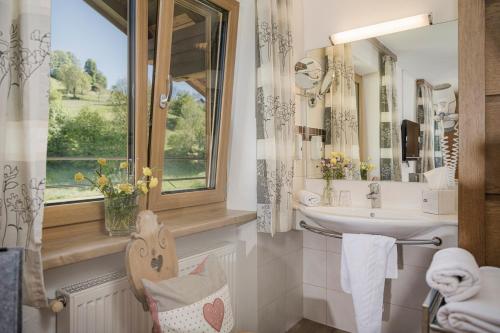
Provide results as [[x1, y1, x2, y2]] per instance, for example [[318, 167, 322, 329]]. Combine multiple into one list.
[[56, 243, 238, 333]]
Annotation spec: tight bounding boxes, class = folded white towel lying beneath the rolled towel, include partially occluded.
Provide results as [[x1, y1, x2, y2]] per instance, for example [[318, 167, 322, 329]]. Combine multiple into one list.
[[437, 266, 500, 333]]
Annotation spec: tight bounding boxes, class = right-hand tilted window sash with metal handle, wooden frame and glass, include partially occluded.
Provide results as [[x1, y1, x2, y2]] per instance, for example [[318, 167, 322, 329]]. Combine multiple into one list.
[[148, 0, 238, 210]]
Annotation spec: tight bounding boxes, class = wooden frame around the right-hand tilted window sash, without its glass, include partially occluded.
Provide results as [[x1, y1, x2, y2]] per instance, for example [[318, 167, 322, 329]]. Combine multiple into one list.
[[148, 0, 239, 211]]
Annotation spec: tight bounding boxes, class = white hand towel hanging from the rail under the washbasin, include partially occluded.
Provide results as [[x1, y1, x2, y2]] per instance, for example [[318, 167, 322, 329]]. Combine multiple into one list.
[[340, 234, 398, 333]]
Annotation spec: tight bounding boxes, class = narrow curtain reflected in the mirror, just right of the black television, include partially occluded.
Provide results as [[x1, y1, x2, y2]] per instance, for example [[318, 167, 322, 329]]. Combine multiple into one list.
[[417, 83, 435, 173]]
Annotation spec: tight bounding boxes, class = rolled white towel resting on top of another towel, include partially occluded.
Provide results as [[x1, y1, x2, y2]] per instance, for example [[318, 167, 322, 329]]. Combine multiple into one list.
[[425, 247, 480, 303]]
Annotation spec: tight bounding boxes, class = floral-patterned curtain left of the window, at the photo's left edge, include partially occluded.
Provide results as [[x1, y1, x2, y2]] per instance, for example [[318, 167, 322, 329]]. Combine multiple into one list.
[[0, 0, 50, 307]]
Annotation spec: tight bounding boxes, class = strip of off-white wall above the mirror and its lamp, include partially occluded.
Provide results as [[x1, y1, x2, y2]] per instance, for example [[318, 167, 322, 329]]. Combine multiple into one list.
[[304, 0, 458, 50]]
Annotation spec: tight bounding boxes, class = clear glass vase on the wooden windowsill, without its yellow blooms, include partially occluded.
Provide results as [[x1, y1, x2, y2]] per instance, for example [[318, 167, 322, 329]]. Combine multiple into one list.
[[104, 194, 139, 236]]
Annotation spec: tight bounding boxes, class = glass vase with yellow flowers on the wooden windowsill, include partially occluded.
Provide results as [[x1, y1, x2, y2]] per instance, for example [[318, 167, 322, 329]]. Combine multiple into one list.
[[75, 158, 158, 236]]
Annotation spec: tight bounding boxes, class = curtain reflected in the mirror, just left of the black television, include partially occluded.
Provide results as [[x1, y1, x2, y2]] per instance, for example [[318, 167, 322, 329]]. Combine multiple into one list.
[[380, 55, 401, 181]]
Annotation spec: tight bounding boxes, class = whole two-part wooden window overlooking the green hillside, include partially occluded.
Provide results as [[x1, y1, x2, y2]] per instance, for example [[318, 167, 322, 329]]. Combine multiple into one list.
[[44, 0, 238, 228]]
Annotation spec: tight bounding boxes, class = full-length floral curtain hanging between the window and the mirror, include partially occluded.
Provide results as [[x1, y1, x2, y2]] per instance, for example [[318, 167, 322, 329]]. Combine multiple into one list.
[[256, 0, 295, 234]]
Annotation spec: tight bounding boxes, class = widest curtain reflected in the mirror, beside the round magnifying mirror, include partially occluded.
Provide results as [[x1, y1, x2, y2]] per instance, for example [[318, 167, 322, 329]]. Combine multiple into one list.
[[325, 44, 359, 171]]
